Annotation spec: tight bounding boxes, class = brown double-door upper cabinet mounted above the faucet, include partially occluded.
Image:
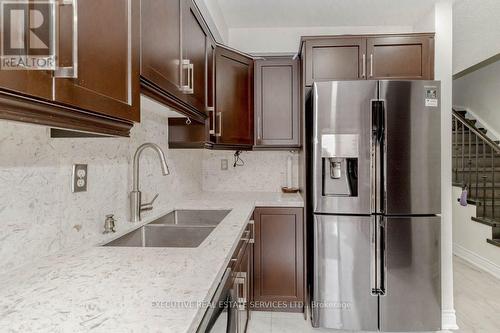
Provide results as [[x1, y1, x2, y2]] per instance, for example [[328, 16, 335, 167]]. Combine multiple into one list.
[[141, 0, 212, 121]]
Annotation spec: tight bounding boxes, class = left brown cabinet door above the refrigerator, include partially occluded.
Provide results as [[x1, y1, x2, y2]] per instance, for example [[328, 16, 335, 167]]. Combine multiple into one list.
[[306, 38, 366, 86]]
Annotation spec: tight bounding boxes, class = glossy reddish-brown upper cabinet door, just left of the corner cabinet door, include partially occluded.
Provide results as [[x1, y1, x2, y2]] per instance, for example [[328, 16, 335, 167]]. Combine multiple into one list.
[[215, 47, 254, 146]]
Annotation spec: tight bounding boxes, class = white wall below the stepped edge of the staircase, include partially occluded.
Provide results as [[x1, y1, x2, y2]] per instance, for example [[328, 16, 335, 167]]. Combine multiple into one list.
[[453, 187, 500, 278]]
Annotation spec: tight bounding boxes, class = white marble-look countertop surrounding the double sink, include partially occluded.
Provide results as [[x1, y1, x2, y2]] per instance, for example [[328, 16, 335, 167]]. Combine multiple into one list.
[[0, 192, 304, 333]]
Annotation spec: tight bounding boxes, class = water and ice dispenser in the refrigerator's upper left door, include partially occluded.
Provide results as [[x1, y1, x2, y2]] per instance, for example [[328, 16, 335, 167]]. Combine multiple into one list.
[[321, 134, 359, 197]]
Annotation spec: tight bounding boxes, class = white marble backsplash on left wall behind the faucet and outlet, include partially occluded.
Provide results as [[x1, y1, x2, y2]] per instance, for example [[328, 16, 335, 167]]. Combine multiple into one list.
[[0, 98, 203, 273]]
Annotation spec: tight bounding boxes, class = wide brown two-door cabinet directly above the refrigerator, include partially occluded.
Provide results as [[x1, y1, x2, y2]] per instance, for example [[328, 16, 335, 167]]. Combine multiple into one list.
[[302, 34, 434, 86]]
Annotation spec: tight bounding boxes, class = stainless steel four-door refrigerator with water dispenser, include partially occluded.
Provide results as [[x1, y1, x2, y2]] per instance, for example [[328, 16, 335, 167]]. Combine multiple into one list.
[[311, 81, 441, 332]]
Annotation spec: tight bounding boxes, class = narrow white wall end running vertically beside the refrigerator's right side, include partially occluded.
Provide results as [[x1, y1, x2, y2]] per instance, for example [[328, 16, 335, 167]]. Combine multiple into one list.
[[434, 0, 457, 329]]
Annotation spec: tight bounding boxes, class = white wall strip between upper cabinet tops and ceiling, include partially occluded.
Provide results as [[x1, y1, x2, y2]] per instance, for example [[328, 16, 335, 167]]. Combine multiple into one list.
[[229, 26, 413, 53]]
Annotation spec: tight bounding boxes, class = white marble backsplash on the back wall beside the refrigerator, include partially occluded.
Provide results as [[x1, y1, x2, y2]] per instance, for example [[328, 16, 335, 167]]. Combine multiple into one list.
[[203, 150, 298, 192]]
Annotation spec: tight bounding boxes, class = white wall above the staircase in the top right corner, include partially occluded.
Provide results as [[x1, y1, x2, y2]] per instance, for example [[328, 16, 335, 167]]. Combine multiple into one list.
[[453, 0, 500, 74]]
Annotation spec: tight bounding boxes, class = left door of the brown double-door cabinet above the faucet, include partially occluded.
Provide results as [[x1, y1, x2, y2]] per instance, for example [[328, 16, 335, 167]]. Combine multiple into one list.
[[141, 0, 183, 96]]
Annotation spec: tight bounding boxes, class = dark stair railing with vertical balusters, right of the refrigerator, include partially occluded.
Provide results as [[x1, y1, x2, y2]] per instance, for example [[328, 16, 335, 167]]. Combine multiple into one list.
[[453, 110, 500, 220]]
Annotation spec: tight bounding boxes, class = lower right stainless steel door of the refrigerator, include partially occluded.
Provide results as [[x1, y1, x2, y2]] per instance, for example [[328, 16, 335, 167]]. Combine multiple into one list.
[[380, 217, 441, 332]]
